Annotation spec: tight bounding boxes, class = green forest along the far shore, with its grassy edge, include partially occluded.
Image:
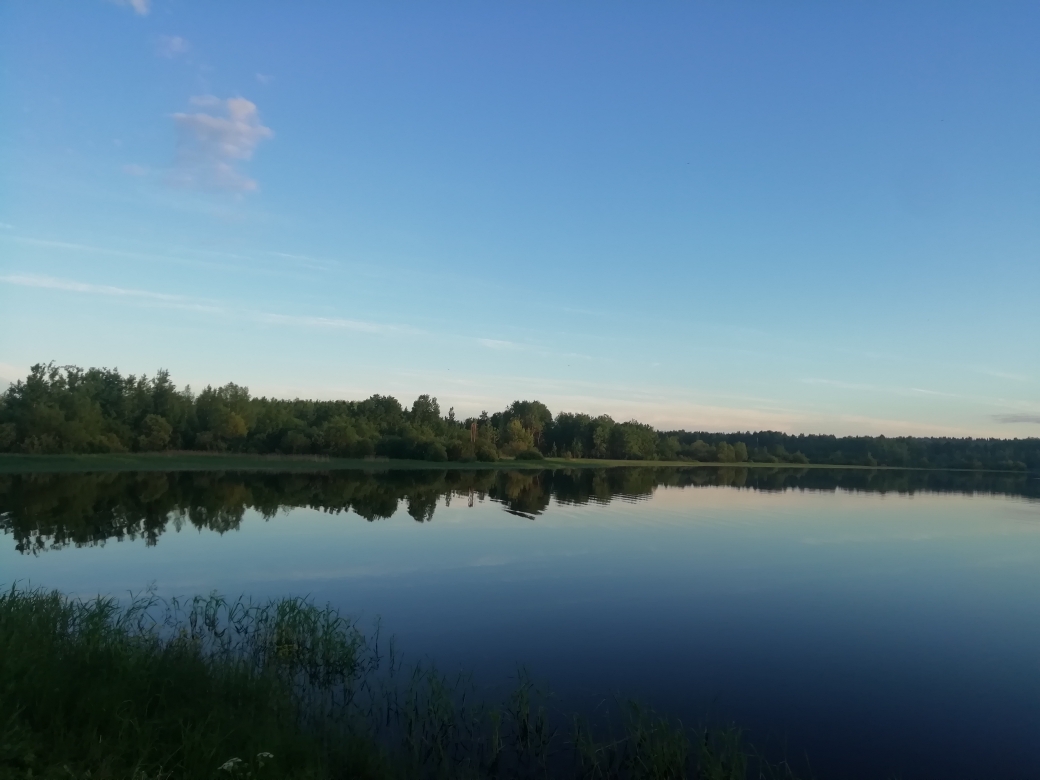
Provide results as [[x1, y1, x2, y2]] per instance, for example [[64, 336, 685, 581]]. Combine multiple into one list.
[[0, 363, 1040, 471]]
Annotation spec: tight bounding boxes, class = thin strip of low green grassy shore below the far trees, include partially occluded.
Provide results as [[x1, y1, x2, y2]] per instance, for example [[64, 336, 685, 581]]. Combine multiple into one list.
[[0, 451, 1029, 476]]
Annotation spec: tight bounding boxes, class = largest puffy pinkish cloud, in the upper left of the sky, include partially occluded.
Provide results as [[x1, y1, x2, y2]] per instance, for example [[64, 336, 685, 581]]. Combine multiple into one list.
[[172, 95, 275, 192]]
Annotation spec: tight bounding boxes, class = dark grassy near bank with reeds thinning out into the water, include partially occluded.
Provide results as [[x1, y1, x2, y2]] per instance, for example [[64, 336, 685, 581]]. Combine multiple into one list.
[[0, 590, 792, 780]]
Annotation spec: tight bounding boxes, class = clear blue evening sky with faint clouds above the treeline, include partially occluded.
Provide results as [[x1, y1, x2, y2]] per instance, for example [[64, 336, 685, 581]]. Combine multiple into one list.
[[0, 0, 1040, 437]]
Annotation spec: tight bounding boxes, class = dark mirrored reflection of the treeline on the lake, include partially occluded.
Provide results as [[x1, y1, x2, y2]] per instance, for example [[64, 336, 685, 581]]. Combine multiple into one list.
[[0, 467, 1040, 552]]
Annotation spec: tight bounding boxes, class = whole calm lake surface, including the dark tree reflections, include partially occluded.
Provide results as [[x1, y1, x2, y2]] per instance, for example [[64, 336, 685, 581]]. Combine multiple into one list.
[[0, 469, 1040, 778]]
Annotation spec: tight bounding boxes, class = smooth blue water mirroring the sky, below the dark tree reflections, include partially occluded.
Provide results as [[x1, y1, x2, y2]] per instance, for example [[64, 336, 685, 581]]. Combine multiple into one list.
[[0, 488, 1040, 777]]
